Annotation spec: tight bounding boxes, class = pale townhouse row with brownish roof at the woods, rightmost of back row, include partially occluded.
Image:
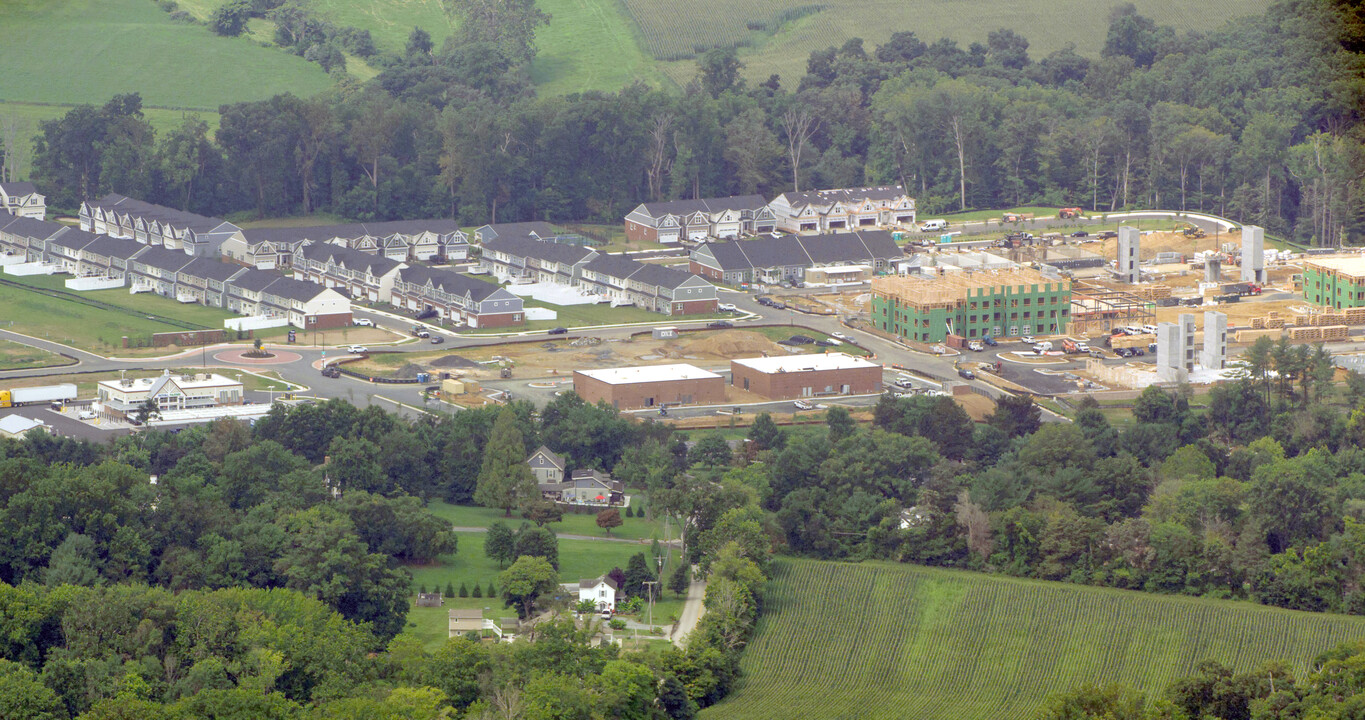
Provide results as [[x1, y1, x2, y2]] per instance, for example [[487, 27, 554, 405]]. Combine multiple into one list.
[[768, 184, 915, 235]]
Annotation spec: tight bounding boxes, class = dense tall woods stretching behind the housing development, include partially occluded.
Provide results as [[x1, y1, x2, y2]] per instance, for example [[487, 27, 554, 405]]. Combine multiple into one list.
[[13, 0, 1365, 245]]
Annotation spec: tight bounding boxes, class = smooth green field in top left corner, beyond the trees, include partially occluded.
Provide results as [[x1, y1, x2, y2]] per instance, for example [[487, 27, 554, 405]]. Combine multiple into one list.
[[0, 0, 332, 111]]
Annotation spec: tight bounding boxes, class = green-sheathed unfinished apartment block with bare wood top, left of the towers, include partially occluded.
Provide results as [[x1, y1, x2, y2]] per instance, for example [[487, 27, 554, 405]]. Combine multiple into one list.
[[872, 268, 1072, 343]]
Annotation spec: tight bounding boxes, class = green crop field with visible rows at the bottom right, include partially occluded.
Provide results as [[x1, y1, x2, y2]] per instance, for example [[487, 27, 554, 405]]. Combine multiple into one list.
[[702, 560, 1365, 720]]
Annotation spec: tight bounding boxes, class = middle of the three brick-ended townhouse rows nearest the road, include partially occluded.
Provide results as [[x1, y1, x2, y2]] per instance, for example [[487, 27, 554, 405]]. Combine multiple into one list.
[[390, 265, 526, 328]]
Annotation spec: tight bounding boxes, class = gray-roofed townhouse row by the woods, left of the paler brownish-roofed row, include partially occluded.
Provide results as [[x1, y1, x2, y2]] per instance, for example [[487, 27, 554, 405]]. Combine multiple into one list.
[[625, 195, 777, 243]]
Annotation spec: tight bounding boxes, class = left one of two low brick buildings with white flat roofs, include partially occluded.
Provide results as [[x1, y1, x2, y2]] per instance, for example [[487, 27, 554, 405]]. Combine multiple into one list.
[[573, 365, 725, 410]]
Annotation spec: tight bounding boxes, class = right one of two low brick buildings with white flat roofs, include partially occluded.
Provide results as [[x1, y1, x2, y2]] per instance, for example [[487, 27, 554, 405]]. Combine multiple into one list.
[[730, 352, 882, 400]]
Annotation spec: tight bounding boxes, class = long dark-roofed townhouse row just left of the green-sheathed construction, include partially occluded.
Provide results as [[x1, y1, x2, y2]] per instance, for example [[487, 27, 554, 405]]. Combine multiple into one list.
[[689, 230, 904, 284]]
